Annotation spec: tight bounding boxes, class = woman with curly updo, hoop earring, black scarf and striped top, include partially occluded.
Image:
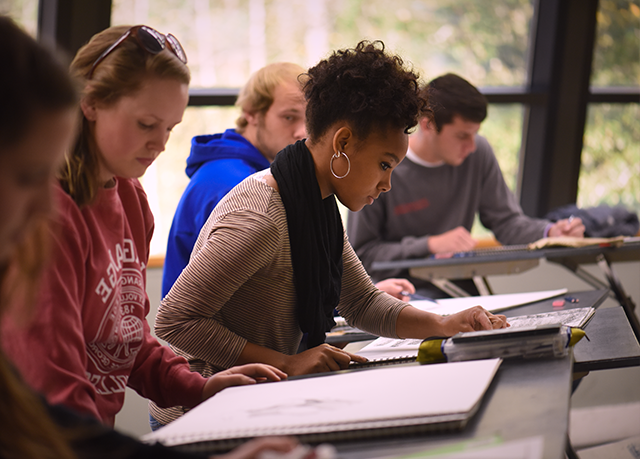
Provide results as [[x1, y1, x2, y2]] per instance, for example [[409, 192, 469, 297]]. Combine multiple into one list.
[[151, 42, 506, 424]]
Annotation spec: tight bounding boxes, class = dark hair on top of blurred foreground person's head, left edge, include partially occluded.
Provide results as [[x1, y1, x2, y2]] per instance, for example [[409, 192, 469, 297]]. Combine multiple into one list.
[[0, 16, 77, 147]]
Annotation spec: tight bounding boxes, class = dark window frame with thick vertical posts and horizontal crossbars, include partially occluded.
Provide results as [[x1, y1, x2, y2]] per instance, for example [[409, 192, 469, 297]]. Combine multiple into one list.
[[38, 0, 640, 221]]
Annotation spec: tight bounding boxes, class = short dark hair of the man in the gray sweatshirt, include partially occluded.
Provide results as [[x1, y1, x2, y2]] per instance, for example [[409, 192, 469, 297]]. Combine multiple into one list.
[[421, 73, 487, 132]]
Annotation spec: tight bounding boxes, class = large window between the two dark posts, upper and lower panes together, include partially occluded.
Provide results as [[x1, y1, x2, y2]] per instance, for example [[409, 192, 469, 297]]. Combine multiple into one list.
[[111, 0, 533, 254]]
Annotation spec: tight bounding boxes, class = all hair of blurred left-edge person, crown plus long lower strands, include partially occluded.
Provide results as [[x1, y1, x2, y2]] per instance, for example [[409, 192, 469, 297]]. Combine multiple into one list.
[[0, 16, 77, 459]]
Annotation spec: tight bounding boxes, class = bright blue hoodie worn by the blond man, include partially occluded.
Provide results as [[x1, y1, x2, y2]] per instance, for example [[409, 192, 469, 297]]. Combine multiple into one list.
[[162, 129, 270, 298]]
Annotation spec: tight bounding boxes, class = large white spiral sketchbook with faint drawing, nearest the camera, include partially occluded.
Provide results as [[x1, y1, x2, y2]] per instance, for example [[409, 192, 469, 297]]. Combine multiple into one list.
[[142, 359, 501, 453]]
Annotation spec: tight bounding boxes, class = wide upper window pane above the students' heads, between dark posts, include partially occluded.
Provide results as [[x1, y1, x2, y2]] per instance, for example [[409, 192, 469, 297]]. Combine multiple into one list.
[[111, 0, 533, 88]]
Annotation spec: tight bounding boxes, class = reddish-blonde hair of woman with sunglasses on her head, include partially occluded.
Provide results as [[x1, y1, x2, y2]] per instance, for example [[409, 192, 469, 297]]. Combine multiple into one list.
[[59, 26, 191, 207]]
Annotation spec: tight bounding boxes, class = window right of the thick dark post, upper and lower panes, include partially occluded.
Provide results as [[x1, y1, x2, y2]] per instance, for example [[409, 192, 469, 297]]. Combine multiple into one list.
[[578, 0, 640, 216]]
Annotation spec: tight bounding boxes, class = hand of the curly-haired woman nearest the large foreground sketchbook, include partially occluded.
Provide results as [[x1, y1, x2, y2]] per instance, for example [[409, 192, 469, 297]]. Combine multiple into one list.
[[283, 343, 367, 376]]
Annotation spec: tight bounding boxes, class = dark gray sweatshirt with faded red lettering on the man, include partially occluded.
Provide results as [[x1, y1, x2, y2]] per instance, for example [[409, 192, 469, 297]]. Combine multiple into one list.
[[347, 135, 549, 282]]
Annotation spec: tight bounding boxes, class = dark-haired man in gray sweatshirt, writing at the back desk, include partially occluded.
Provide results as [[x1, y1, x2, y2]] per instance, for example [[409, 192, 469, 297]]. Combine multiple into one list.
[[347, 74, 584, 296]]
